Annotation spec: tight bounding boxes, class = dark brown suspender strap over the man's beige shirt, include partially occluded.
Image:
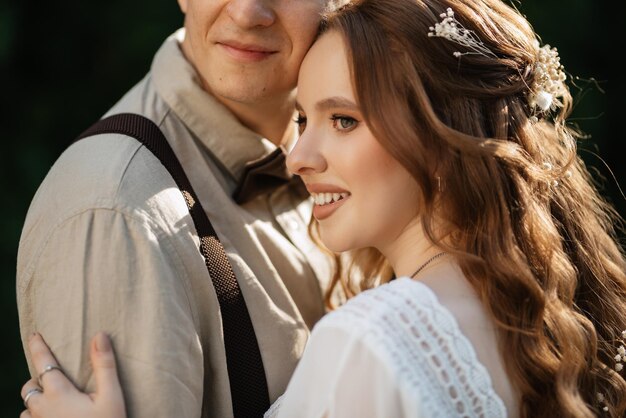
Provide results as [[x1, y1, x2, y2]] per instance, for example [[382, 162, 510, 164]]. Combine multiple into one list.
[[77, 113, 270, 418]]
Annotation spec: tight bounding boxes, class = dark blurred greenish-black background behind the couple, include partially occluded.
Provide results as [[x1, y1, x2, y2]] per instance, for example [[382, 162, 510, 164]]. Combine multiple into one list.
[[0, 0, 626, 417]]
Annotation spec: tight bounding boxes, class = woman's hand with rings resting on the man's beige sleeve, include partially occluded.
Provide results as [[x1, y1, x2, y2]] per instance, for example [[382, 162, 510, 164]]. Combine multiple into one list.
[[20, 333, 126, 418]]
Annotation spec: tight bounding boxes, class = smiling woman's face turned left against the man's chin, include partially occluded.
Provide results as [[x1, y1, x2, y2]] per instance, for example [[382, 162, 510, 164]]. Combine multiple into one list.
[[287, 31, 418, 252]]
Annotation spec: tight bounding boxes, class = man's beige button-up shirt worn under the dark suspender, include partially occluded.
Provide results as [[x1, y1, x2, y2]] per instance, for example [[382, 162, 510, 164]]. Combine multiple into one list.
[[17, 31, 329, 418]]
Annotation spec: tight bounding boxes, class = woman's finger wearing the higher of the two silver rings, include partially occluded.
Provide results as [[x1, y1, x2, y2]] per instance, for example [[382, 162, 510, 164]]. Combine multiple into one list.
[[28, 333, 73, 391]]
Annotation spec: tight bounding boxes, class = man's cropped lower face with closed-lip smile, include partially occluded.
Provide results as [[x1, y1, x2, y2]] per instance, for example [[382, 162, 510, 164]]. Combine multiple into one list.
[[179, 0, 326, 105]]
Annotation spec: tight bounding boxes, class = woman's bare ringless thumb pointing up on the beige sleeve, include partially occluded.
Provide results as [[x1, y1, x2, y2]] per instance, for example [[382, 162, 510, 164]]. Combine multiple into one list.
[[91, 332, 122, 398]]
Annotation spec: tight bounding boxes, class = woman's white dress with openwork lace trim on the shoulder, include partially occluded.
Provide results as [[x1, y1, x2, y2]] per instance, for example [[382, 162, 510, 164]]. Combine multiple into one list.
[[265, 278, 506, 418]]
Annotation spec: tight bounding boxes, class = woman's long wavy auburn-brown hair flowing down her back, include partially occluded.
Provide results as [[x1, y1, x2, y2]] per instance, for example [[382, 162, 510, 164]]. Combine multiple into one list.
[[313, 0, 626, 418]]
